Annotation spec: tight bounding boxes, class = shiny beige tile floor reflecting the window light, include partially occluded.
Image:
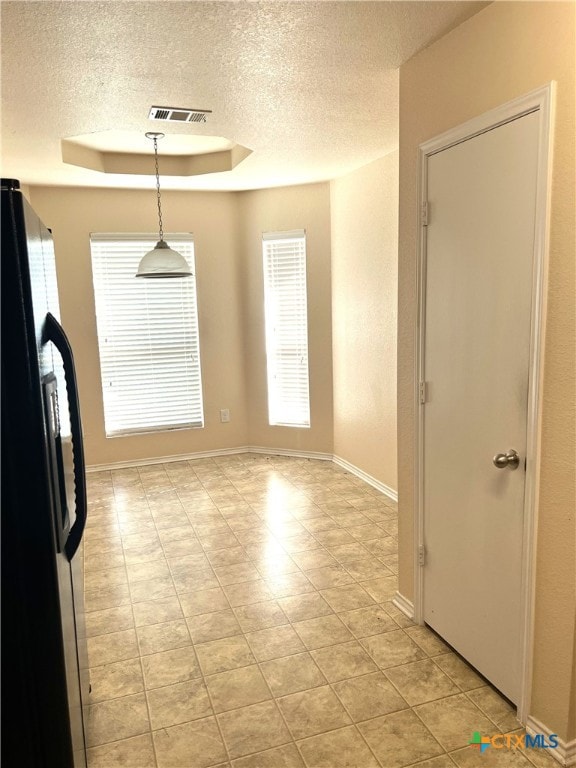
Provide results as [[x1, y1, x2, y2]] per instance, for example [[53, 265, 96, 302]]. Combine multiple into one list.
[[85, 454, 554, 768]]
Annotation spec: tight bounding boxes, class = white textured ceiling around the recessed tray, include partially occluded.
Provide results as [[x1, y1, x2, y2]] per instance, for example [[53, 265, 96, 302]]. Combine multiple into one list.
[[0, 0, 487, 190]]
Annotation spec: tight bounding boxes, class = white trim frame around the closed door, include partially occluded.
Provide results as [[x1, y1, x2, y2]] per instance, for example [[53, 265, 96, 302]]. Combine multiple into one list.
[[414, 82, 555, 724]]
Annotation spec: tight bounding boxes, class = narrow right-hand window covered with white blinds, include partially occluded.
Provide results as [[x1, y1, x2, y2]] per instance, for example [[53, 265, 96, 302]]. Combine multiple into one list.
[[262, 230, 310, 427]]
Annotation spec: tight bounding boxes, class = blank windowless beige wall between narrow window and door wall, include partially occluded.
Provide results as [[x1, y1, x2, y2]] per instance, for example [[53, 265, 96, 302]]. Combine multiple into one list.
[[330, 152, 398, 491]]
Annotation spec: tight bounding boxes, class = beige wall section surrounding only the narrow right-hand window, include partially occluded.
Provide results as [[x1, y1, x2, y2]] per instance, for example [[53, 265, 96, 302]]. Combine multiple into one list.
[[239, 184, 332, 453]]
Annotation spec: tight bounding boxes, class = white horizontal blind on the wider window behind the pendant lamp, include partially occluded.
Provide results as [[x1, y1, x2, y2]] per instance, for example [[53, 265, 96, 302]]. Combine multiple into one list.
[[90, 234, 204, 437]]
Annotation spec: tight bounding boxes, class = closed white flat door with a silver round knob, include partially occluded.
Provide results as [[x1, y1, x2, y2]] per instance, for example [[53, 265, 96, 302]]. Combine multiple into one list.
[[423, 113, 538, 703]]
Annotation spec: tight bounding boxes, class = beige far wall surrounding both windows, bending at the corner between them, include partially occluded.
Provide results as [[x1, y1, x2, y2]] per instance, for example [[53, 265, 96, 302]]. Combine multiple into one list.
[[30, 184, 332, 464]]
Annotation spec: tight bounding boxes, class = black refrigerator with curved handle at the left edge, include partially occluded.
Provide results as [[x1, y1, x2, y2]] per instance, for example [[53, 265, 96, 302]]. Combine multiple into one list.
[[0, 179, 89, 768]]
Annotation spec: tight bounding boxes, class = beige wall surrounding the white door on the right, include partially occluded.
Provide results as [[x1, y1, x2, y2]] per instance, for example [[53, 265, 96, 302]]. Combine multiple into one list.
[[398, 2, 576, 739]]
